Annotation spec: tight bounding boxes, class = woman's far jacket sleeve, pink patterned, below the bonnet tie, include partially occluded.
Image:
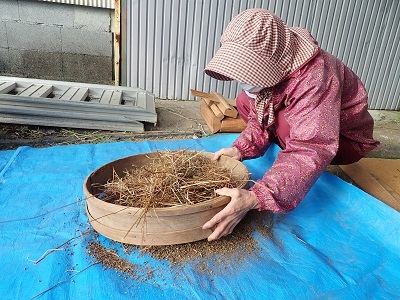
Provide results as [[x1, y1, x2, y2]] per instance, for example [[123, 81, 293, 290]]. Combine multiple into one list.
[[232, 97, 271, 160]]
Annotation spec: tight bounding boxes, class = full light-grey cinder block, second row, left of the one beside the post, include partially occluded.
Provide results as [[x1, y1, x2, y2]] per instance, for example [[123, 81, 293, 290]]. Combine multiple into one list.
[[6, 21, 61, 52]]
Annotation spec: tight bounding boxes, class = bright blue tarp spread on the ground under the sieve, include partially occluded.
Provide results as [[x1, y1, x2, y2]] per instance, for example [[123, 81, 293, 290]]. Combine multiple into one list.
[[0, 134, 400, 299]]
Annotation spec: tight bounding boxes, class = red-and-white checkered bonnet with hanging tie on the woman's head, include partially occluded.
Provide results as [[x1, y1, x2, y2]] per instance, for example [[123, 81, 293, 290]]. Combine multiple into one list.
[[205, 9, 318, 125]]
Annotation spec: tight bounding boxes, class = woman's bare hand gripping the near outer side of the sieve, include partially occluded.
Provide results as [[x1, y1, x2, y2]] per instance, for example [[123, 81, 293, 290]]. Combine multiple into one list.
[[203, 187, 258, 241]]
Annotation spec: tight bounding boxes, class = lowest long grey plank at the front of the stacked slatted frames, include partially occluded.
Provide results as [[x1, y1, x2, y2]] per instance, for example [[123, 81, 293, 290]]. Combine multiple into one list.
[[0, 112, 144, 133]]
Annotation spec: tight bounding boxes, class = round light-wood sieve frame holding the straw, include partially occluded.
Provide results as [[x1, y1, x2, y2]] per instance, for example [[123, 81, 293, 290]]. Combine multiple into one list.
[[83, 152, 250, 245]]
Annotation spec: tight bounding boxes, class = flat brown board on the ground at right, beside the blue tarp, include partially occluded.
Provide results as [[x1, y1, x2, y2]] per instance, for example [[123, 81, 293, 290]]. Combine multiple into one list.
[[340, 158, 400, 211]]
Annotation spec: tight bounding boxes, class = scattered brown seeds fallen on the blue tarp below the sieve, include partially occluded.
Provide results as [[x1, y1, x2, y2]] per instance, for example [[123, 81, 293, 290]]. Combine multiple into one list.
[[87, 211, 279, 280]]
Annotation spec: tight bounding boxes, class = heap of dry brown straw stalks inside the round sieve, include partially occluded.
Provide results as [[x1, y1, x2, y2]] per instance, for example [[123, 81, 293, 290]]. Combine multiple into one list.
[[102, 150, 239, 210]]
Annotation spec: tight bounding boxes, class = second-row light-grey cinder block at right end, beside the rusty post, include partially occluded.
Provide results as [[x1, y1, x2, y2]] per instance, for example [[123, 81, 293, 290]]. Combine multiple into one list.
[[61, 28, 113, 57]]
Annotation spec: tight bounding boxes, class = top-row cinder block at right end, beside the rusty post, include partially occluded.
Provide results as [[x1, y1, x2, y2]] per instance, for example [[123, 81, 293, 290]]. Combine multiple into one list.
[[74, 6, 111, 32]]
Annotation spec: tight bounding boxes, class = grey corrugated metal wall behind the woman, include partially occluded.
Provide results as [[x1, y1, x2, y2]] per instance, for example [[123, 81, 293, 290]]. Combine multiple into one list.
[[122, 0, 400, 110]]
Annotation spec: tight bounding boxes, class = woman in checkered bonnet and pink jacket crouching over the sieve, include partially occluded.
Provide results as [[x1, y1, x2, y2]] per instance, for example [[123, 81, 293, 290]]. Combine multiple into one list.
[[203, 9, 379, 241]]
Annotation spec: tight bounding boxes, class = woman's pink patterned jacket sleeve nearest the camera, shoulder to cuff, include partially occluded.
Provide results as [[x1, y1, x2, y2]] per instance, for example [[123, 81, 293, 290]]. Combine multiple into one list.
[[251, 71, 341, 213]]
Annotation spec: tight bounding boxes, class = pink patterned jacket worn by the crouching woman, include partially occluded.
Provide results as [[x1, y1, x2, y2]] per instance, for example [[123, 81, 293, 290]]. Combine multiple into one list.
[[232, 50, 379, 213]]
